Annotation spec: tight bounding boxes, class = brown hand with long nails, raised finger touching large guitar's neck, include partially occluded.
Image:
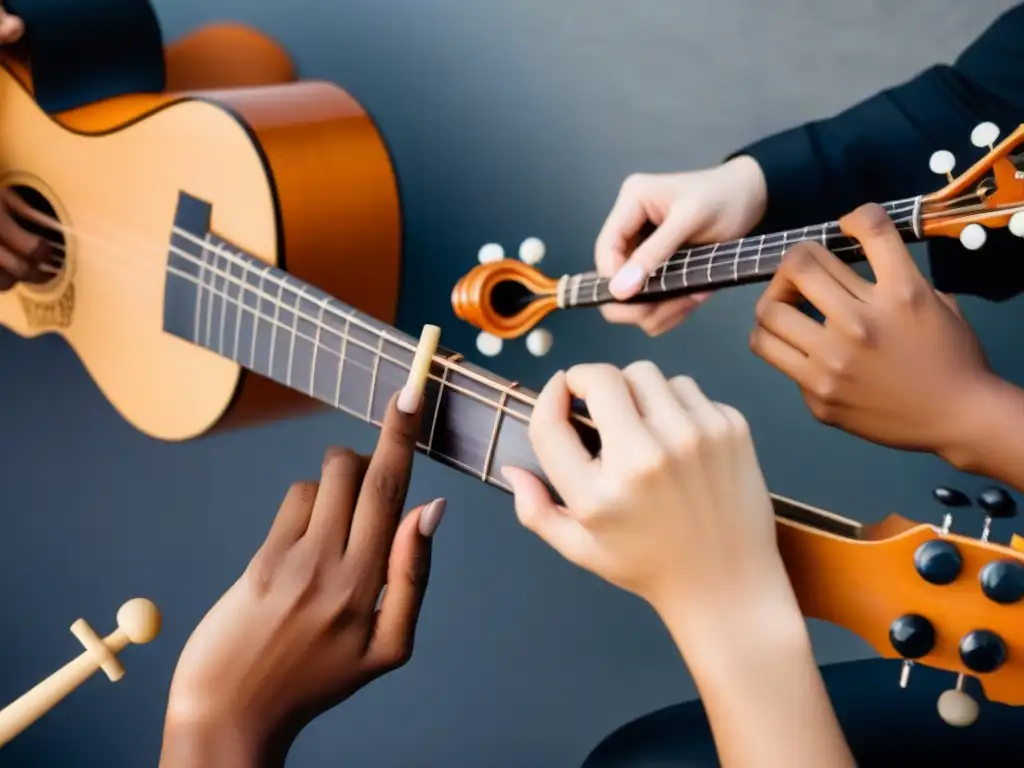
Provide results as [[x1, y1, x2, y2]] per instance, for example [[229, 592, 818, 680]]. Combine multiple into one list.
[[161, 401, 444, 768]]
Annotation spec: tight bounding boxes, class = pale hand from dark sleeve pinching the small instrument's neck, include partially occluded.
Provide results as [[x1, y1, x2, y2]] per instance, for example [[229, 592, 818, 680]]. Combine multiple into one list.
[[594, 156, 768, 336]]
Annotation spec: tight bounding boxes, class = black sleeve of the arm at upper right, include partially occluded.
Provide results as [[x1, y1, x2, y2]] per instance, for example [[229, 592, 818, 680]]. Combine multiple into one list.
[[735, 3, 1024, 300]]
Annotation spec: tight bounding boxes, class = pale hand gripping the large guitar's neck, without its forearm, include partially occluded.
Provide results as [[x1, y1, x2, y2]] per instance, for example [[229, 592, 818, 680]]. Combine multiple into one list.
[[503, 361, 782, 626]]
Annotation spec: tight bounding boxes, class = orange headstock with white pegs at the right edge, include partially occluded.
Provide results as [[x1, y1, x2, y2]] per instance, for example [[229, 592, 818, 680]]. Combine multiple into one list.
[[920, 123, 1024, 251]]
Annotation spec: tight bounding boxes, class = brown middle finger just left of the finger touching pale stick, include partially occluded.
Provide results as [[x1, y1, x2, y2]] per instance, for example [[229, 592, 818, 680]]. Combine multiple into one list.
[[307, 447, 370, 557]]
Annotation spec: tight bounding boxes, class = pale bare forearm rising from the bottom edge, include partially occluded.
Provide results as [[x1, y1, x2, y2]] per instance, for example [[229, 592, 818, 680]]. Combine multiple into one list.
[[666, 582, 854, 768]]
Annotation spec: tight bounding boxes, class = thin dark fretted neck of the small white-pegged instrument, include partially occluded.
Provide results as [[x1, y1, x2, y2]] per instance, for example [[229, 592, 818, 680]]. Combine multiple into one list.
[[557, 198, 921, 309]]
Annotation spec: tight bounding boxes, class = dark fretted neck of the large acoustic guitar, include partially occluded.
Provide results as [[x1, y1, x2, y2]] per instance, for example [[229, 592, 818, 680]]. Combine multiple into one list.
[[164, 195, 861, 539]]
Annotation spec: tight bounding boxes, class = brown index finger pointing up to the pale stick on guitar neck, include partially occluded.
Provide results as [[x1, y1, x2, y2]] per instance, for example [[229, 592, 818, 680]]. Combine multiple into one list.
[[349, 397, 420, 578]]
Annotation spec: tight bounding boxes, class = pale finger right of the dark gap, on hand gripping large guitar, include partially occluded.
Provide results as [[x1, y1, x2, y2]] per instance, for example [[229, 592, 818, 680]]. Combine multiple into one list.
[[565, 364, 656, 458]]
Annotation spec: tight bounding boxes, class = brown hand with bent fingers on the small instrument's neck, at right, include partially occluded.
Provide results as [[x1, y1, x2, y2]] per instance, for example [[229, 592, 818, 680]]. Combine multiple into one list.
[[751, 205, 991, 459]]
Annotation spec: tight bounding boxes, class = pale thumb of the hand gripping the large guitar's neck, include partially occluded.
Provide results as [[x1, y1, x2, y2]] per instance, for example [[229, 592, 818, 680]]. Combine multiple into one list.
[[502, 467, 590, 567]]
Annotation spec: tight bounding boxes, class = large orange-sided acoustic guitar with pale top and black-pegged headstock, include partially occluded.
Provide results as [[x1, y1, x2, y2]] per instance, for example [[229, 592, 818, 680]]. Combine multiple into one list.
[[0, 54, 1024, 724]]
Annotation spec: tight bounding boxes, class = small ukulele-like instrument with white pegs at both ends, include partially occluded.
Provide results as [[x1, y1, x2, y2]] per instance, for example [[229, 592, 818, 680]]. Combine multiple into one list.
[[452, 123, 1024, 339]]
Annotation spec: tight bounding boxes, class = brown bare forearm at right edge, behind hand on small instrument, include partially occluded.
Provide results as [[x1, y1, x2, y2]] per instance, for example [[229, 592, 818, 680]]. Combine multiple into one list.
[[939, 374, 1024, 492]]
